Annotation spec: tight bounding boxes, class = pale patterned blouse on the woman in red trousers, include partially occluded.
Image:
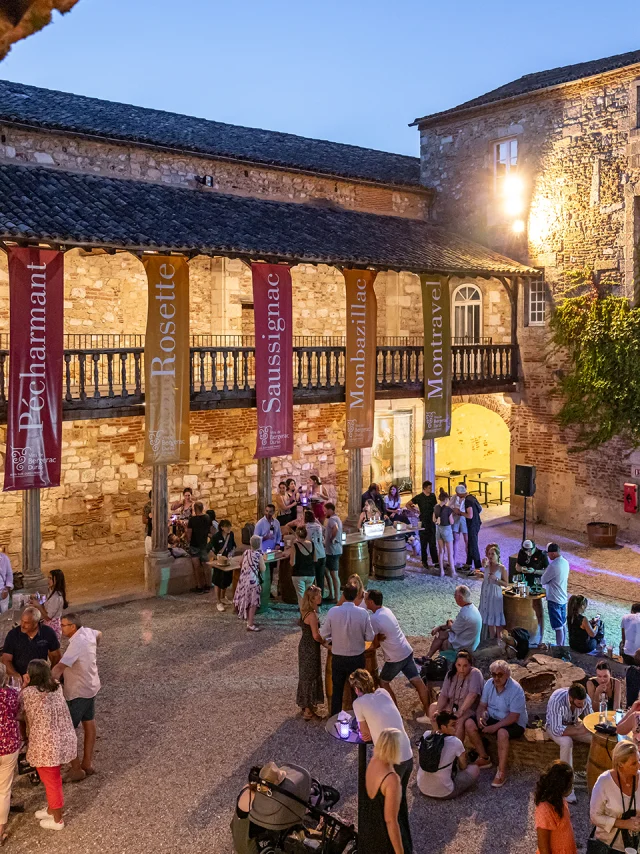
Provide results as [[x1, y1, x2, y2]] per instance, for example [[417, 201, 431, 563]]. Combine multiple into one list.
[[22, 685, 78, 768]]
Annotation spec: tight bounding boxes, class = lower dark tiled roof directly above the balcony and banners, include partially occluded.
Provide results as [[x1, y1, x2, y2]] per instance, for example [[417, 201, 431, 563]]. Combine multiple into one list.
[[0, 164, 533, 275]]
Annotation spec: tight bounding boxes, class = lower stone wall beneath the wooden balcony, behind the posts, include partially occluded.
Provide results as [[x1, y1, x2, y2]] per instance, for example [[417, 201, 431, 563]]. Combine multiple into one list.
[[0, 404, 347, 567]]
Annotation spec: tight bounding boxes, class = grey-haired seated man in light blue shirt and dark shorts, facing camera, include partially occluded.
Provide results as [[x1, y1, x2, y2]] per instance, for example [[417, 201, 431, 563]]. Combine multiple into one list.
[[465, 660, 528, 789]]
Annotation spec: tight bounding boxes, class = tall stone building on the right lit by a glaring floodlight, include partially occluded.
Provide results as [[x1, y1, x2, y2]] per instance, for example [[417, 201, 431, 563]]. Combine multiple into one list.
[[415, 51, 640, 539]]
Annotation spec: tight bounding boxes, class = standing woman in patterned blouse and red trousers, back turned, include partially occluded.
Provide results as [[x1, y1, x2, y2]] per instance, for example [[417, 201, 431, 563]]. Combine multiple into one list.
[[22, 658, 78, 830]]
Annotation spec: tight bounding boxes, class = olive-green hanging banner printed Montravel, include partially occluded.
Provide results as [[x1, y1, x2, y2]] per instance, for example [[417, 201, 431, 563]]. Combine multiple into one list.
[[420, 275, 451, 439]]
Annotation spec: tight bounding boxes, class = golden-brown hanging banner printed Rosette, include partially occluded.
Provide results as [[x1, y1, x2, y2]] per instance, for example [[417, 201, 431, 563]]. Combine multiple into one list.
[[143, 255, 190, 465]]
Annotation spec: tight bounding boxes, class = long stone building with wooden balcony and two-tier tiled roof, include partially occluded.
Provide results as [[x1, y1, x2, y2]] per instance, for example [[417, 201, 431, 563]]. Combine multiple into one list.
[[0, 82, 536, 576]]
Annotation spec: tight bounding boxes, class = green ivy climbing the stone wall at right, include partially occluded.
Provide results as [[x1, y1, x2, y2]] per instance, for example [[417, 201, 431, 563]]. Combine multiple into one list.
[[551, 270, 640, 451]]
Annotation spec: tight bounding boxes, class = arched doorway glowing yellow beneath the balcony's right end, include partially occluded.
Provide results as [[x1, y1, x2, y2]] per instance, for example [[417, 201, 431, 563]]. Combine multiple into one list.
[[435, 403, 511, 516]]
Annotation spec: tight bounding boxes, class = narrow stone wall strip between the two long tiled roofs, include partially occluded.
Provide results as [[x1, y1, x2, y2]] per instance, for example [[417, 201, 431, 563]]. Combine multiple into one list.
[[0, 125, 430, 219]]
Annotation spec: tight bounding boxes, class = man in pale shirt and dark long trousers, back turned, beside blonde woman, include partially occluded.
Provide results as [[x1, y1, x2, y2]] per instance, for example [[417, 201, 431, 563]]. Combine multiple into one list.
[[320, 584, 374, 715]]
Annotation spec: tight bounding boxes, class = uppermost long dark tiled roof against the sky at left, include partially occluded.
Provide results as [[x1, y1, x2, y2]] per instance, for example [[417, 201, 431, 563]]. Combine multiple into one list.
[[0, 80, 420, 187]]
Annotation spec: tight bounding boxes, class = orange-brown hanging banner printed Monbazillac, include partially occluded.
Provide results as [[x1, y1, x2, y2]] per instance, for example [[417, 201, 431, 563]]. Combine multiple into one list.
[[342, 270, 378, 448]]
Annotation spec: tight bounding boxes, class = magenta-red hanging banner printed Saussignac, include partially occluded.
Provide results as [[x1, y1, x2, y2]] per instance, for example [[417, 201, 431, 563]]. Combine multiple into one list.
[[251, 264, 293, 459]]
